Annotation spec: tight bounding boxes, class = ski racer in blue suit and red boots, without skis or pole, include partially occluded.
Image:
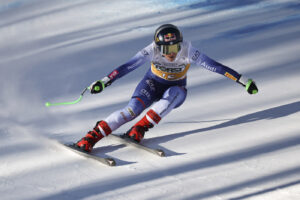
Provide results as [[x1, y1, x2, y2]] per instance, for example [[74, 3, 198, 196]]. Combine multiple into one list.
[[75, 24, 258, 152]]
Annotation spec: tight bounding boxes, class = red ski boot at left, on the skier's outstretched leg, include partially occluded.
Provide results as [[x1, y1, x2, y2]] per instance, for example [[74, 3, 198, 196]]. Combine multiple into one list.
[[74, 121, 111, 152]]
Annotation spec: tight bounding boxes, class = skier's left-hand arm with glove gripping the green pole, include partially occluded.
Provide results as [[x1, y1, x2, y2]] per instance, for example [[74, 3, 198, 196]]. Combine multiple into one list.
[[89, 44, 152, 94]]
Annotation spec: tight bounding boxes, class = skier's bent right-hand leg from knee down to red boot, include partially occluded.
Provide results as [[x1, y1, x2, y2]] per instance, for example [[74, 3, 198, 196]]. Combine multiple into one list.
[[126, 86, 187, 142]]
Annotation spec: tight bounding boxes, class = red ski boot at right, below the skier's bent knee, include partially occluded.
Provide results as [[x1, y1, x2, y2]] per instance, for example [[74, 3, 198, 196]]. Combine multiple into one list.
[[124, 110, 161, 143]]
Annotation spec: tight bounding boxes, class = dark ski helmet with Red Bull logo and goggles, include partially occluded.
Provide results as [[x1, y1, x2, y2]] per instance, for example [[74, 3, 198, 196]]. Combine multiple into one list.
[[154, 24, 182, 54]]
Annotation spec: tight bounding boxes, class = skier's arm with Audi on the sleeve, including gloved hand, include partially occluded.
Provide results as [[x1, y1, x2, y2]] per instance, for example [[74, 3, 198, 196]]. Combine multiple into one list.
[[189, 46, 258, 94]]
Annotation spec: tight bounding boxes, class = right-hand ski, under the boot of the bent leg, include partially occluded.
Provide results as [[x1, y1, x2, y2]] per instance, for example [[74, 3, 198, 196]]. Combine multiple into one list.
[[109, 134, 165, 157]]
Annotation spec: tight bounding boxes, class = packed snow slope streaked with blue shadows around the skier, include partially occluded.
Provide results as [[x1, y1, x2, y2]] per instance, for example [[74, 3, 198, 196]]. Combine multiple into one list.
[[0, 0, 300, 200]]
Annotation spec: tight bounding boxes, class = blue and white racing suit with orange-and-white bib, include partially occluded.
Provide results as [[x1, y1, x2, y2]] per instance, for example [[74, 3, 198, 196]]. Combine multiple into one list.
[[105, 41, 241, 131]]
